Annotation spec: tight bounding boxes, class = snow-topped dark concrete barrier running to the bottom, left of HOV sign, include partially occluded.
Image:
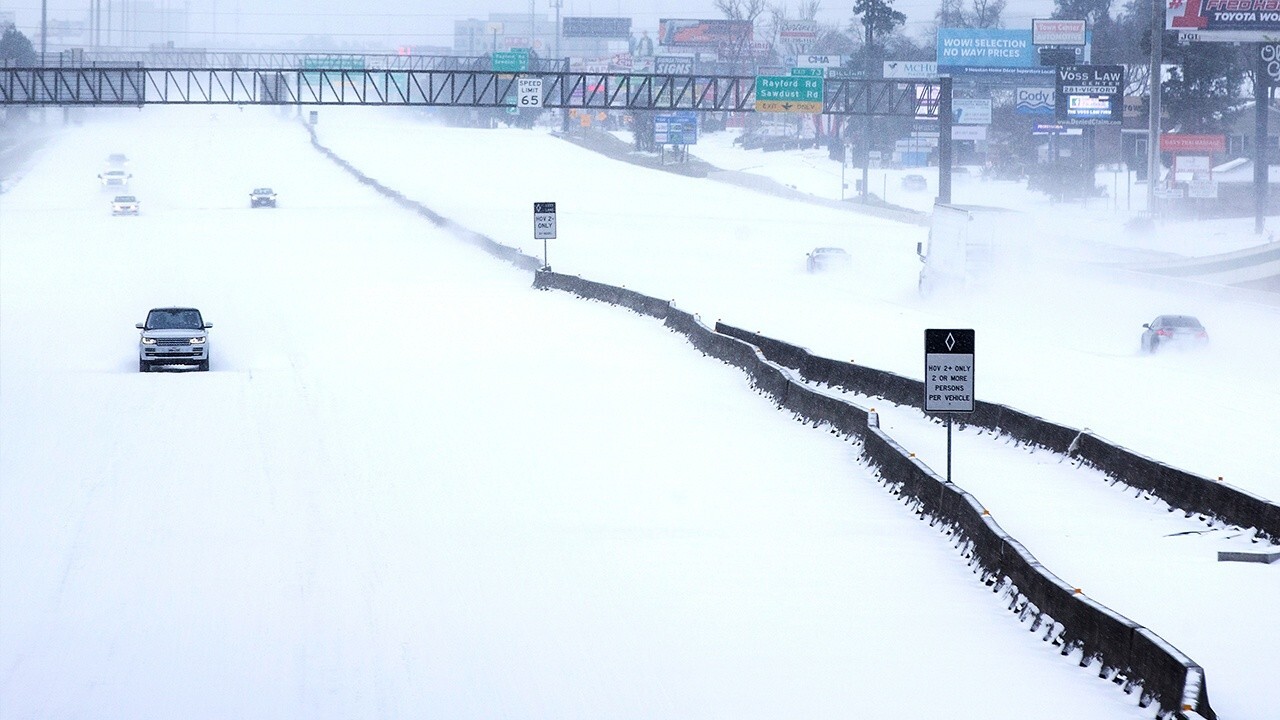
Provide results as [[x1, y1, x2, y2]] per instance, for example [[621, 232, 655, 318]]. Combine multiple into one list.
[[534, 270, 1216, 720]]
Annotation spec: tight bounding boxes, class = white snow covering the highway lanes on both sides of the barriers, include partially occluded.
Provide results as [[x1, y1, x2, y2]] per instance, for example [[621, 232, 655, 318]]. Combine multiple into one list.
[[0, 109, 1276, 720]]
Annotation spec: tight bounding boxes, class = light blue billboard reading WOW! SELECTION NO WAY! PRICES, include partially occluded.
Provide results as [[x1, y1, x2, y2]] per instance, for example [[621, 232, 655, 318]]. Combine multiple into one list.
[[938, 27, 1053, 77]]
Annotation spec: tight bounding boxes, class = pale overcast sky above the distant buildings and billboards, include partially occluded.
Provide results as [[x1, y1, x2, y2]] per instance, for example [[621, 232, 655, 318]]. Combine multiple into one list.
[[0, 0, 1052, 49]]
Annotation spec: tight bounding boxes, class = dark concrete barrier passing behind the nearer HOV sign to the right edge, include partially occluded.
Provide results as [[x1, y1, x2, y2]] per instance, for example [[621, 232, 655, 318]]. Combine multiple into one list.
[[716, 323, 1280, 543]]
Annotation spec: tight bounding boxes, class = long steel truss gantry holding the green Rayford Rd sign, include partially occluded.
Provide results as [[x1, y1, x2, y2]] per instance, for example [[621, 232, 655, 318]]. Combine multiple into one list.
[[0, 67, 946, 119]]
